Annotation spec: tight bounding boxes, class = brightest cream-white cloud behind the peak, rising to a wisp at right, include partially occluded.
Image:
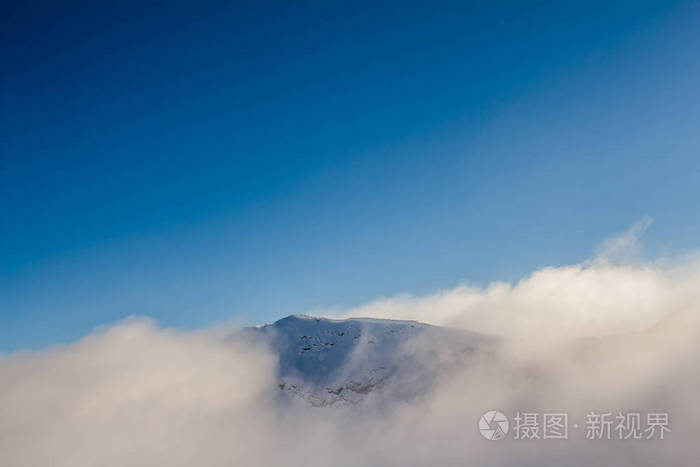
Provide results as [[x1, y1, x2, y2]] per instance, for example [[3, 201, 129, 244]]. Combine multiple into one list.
[[328, 219, 700, 339]]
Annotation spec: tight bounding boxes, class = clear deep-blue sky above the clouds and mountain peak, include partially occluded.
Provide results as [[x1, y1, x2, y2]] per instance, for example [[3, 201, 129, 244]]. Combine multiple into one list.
[[0, 1, 700, 351]]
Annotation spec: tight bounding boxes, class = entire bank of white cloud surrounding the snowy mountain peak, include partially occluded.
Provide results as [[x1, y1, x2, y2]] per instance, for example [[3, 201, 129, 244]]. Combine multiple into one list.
[[0, 221, 700, 467]]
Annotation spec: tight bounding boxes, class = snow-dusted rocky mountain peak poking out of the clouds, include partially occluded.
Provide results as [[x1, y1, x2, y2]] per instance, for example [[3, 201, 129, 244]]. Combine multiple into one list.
[[239, 315, 494, 407]]
